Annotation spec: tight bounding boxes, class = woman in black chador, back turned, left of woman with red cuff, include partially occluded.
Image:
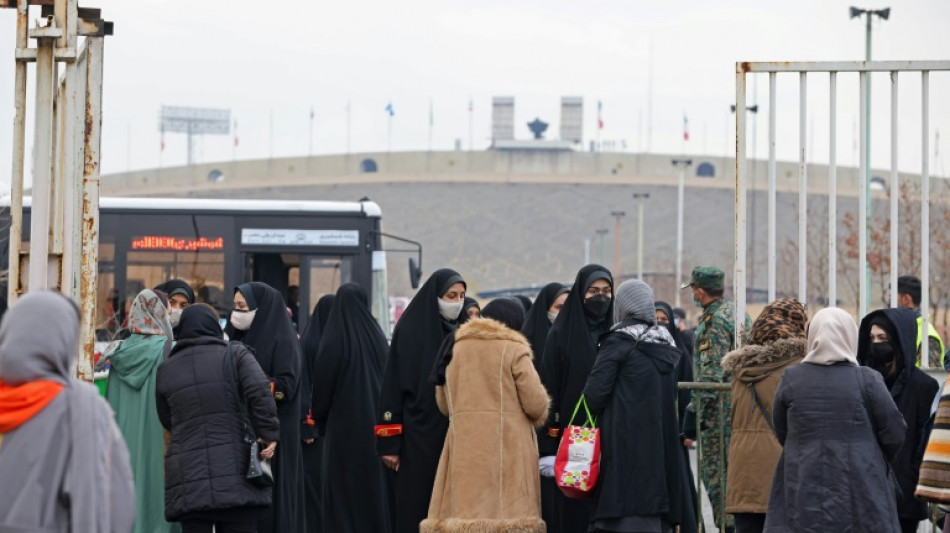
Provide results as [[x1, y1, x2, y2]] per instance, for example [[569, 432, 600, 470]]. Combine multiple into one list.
[[313, 283, 390, 533]]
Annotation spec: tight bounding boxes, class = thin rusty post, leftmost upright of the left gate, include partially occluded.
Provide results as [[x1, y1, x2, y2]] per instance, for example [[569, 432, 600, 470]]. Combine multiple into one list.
[[7, 0, 29, 305]]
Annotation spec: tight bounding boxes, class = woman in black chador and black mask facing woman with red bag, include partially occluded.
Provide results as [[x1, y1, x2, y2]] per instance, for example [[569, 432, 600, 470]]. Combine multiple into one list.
[[538, 265, 613, 533]]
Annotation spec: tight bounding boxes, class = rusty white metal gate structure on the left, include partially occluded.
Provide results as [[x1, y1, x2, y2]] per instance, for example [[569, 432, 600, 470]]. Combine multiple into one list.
[[0, 0, 112, 381]]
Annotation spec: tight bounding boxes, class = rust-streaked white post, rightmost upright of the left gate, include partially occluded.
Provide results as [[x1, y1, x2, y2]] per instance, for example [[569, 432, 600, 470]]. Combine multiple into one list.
[[78, 37, 104, 381]]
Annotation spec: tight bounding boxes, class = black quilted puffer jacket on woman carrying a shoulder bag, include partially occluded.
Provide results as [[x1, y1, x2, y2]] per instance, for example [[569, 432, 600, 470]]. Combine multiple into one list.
[[155, 337, 279, 521]]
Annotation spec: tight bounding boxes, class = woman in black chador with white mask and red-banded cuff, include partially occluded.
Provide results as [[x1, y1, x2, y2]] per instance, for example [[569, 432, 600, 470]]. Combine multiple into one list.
[[376, 268, 465, 533]]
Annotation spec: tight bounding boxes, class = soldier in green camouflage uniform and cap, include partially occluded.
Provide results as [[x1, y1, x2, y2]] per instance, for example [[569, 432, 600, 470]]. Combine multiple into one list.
[[682, 267, 752, 531]]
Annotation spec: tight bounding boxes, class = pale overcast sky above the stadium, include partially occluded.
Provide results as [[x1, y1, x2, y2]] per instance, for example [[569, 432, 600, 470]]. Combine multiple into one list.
[[0, 0, 950, 183]]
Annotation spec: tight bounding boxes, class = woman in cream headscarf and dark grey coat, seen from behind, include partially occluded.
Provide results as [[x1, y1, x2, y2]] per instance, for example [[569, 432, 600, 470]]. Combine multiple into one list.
[[765, 308, 907, 533]]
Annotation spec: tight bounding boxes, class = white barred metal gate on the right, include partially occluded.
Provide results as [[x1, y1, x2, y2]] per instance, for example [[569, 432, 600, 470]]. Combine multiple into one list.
[[734, 61, 950, 348]]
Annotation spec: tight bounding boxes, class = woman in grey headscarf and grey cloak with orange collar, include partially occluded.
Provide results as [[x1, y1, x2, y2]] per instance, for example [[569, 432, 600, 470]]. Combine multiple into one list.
[[0, 291, 135, 533]]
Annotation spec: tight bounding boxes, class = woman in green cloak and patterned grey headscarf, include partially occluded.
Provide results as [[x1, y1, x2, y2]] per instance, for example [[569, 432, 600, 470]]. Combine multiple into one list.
[[106, 289, 178, 533]]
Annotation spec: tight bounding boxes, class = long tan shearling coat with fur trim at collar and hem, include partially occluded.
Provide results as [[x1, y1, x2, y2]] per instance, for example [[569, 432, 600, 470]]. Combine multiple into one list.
[[420, 318, 550, 533]]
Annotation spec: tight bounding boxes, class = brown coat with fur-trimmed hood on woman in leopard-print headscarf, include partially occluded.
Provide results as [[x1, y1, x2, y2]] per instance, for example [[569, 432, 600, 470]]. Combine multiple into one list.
[[722, 338, 805, 513]]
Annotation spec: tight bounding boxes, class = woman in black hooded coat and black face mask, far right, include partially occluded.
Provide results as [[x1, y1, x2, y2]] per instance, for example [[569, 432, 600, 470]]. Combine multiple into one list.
[[858, 309, 940, 533]]
